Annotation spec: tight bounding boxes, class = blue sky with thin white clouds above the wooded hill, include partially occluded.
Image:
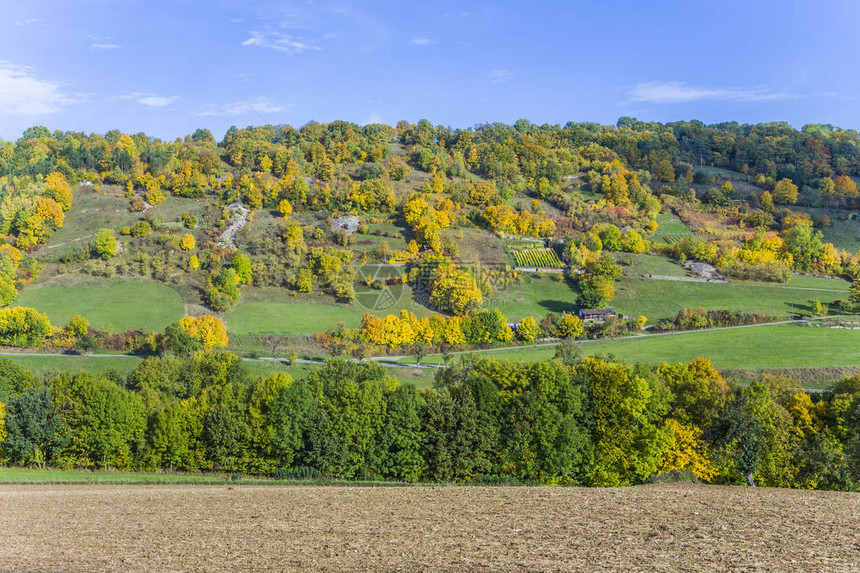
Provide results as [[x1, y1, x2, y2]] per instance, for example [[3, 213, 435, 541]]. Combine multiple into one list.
[[0, 0, 860, 139]]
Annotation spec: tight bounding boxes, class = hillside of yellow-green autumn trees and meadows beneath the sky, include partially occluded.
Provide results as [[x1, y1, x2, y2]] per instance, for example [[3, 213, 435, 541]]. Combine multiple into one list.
[[0, 118, 860, 380]]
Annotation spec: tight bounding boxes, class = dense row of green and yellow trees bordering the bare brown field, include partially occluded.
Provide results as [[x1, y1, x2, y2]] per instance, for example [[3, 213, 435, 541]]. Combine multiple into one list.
[[0, 345, 860, 490]]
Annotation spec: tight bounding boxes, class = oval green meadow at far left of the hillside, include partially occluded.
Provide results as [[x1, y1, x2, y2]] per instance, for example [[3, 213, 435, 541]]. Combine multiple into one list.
[[15, 279, 183, 332]]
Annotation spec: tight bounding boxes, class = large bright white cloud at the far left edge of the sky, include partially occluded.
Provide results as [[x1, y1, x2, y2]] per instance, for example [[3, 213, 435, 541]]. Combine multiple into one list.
[[0, 61, 70, 115]]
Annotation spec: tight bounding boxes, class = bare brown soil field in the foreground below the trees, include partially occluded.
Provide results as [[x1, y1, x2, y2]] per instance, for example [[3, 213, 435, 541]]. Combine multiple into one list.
[[0, 484, 860, 571]]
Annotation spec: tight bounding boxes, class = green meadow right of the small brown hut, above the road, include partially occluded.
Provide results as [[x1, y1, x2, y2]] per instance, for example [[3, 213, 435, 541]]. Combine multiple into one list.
[[610, 273, 849, 323]]
